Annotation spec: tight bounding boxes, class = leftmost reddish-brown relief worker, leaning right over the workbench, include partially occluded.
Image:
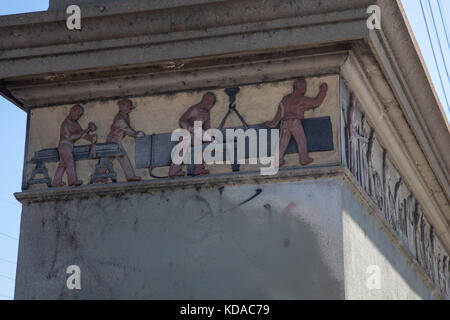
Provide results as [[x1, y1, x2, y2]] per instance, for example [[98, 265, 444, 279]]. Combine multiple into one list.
[[53, 104, 97, 187]]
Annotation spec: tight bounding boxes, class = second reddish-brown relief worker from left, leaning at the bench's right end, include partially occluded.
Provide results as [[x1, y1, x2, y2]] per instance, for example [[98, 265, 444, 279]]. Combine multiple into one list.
[[95, 99, 144, 183]]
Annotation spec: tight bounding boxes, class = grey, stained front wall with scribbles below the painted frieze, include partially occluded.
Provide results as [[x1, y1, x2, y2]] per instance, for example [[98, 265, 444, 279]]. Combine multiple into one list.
[[15, 179, 344, 299]]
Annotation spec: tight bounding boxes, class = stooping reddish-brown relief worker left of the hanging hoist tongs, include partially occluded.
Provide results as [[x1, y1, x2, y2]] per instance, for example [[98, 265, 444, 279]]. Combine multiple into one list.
[[169, 92, 216, 177]]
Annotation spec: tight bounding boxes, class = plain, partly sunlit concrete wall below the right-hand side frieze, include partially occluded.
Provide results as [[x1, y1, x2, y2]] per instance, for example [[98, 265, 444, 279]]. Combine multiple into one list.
[[342, 187, 436, 300]]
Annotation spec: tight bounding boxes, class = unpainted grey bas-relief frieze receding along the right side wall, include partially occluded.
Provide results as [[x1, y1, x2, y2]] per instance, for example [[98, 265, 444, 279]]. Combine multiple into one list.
[[342, 87, 450, 297]]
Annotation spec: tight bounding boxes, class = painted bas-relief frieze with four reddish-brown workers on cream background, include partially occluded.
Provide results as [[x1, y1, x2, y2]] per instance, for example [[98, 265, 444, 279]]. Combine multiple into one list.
[[25, 76, 339, 189]]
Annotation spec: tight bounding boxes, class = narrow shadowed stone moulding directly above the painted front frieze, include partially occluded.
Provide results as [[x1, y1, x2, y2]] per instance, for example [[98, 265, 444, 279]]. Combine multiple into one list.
[[4, 46, 348, 108]]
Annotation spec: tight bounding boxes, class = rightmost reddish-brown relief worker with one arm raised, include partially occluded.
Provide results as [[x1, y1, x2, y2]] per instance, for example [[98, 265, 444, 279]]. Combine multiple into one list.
[[265, 79, 328, 167]]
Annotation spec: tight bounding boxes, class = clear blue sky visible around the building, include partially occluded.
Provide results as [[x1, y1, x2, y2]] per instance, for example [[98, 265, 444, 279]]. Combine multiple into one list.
[[0, 0, 450, 300]]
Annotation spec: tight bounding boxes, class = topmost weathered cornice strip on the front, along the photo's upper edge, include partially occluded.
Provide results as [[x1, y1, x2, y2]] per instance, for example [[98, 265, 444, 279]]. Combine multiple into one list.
[[0, 0, 371, 27]]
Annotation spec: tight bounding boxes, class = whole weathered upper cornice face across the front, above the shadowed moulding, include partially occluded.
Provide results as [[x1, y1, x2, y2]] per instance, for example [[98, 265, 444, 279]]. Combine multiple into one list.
[[0, 0, 368, 80]]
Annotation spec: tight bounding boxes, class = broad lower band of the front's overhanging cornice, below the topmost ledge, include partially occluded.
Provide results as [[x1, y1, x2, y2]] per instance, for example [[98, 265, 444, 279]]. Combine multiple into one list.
[[0, 9, 367, 80]]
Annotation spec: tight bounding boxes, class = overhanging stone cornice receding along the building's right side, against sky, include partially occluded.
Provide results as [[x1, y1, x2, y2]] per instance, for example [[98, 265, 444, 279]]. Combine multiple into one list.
[[369, 0, 450, 200]]
